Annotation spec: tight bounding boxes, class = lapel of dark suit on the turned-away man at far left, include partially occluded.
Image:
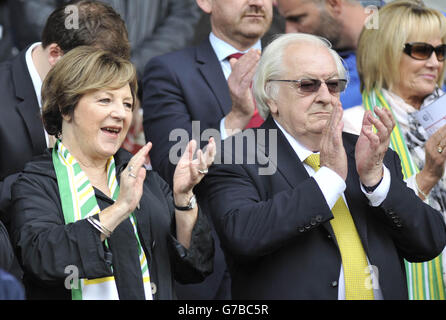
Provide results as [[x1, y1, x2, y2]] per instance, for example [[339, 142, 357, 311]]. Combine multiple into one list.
[[12, 50, 47, 154]]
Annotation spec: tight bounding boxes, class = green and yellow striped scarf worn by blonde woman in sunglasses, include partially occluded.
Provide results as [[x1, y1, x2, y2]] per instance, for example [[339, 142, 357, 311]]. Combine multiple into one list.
[[363, 90, 446, 300]]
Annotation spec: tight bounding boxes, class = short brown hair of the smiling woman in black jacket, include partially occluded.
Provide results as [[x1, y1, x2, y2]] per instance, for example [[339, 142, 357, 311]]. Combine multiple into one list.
[[42, 46, 138, 137]]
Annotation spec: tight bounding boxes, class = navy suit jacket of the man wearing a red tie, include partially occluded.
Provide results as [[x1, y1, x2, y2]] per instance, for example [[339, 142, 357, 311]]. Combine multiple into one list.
[[143, 39, 231, 300]]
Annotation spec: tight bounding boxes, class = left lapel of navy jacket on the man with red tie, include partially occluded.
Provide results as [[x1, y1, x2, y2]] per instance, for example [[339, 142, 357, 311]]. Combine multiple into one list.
[[196, 39, 232, 115]]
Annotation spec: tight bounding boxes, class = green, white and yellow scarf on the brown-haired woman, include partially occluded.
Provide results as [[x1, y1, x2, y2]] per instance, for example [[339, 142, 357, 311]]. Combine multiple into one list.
[[52, 140, 153, 300]]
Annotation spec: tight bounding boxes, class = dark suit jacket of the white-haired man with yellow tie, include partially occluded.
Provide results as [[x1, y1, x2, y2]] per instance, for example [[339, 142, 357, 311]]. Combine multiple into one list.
[[200, 118, 446, 299]]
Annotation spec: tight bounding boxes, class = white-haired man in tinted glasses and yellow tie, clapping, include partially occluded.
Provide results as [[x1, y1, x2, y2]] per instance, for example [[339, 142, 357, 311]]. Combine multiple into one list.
[[198, 33, 446, 299]]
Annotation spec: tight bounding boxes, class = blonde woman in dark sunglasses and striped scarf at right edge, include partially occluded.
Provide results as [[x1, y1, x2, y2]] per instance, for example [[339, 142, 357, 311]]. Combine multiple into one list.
[[344, 0, 446, 299]]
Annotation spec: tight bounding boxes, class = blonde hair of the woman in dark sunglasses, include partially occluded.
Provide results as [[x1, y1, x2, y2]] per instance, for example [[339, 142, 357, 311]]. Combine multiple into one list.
[[357, 0, 446, 92]]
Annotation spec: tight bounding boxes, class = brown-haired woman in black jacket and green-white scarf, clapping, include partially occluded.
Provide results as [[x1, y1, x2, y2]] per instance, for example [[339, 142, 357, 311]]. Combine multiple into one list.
[[11, 47, 215, 299]]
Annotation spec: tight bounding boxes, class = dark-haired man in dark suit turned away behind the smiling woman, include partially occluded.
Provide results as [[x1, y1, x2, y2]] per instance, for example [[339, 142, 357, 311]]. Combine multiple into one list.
[[0, 1, 130, 277]]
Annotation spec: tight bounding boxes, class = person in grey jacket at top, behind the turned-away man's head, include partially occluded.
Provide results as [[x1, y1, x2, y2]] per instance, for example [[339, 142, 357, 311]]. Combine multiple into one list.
[[7, 0, 201, 77]]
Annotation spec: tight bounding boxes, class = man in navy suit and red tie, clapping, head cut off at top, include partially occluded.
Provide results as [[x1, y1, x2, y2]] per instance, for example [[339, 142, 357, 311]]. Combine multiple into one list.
[[143, 0, 272, 299]]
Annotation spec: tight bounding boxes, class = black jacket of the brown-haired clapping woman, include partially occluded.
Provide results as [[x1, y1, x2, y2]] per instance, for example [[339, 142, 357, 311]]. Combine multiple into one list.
[[11, 149, 214, 300]]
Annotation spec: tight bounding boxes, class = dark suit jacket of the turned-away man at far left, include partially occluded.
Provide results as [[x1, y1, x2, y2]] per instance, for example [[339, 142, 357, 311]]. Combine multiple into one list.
[[0, 49, 46, 225]]
